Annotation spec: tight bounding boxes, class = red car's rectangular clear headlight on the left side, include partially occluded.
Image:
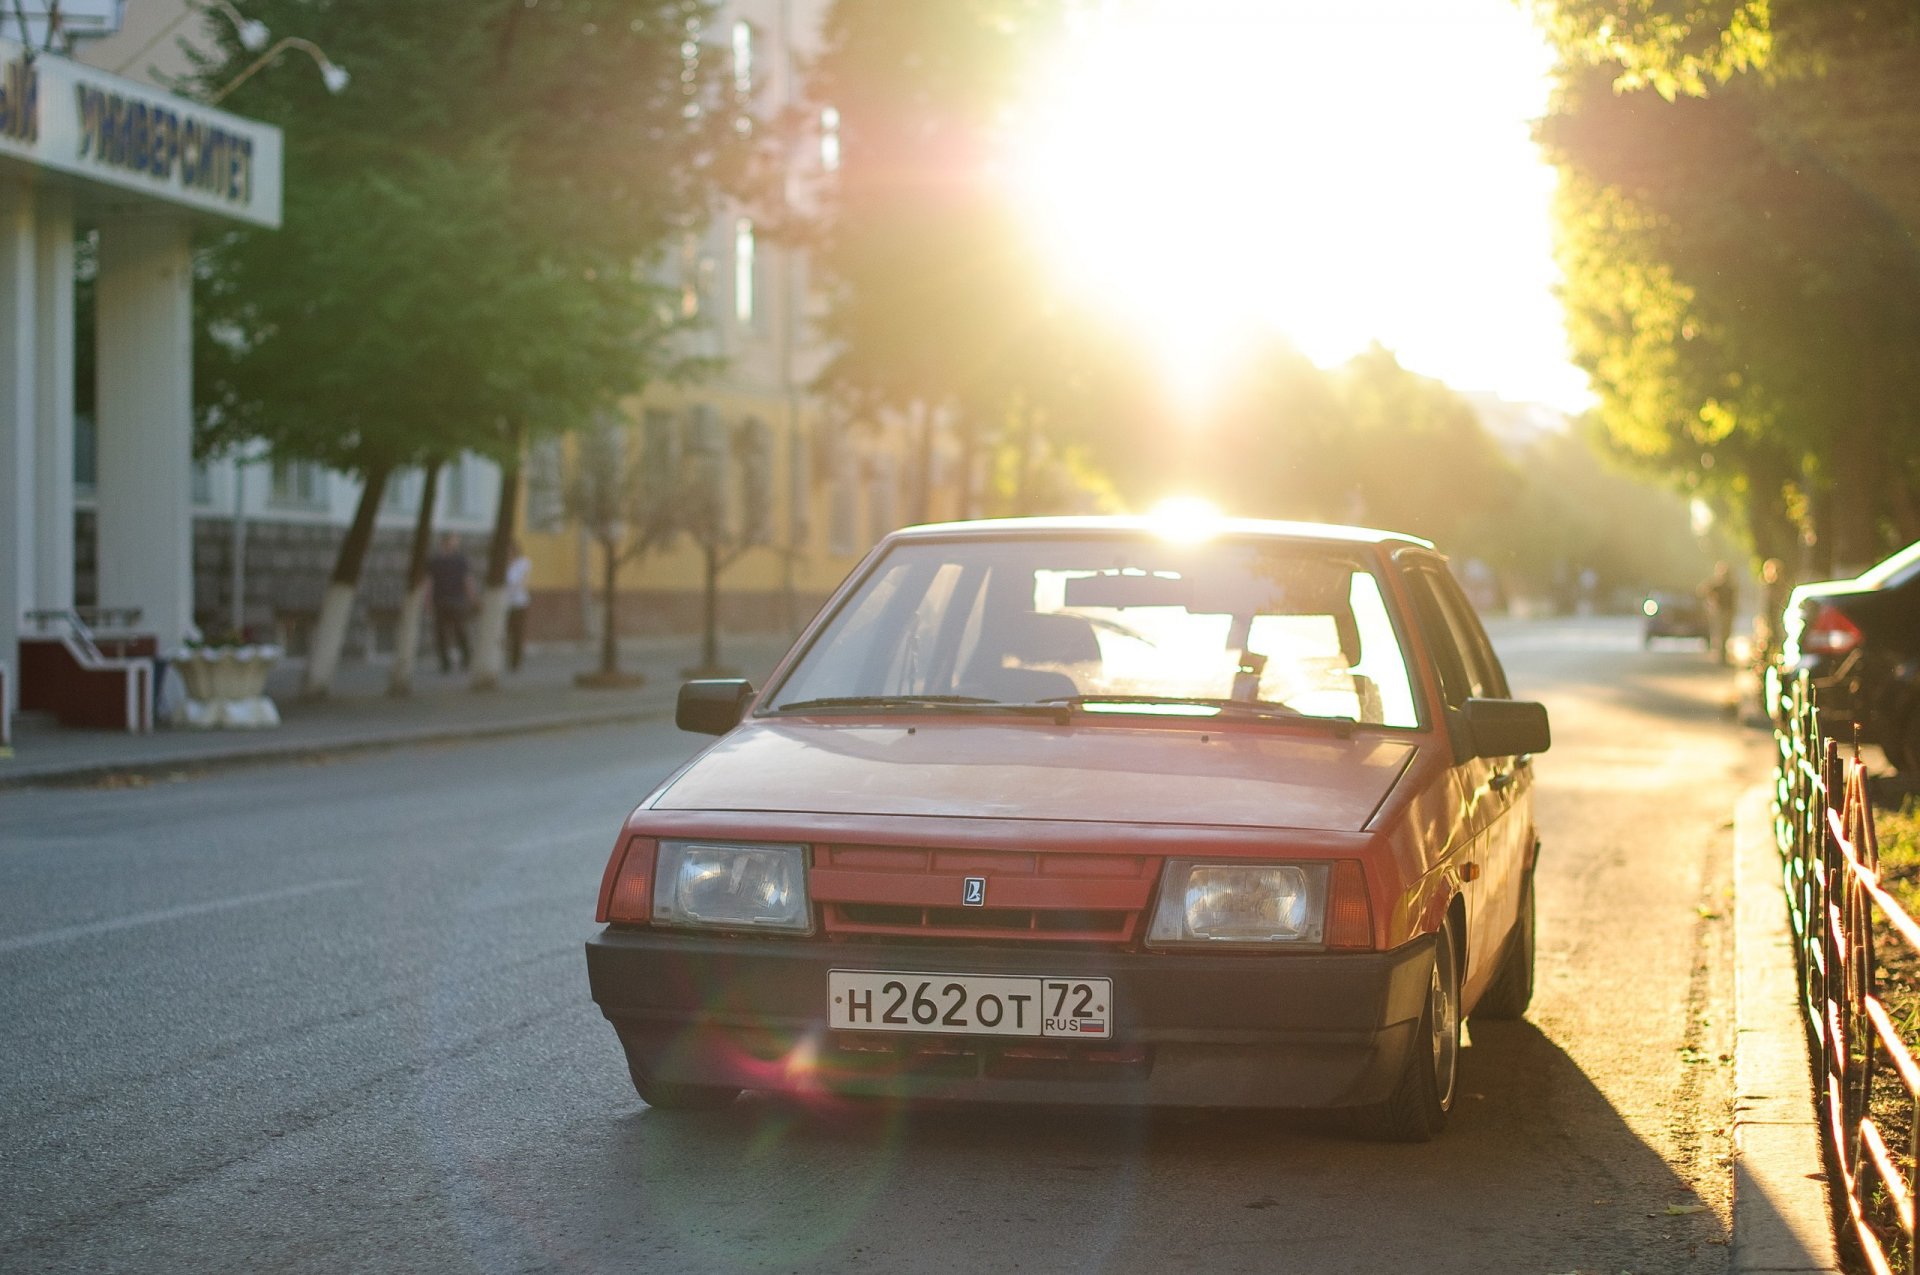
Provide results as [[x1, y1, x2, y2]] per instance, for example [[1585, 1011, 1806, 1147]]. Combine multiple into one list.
[[653, 841, 814, 933]]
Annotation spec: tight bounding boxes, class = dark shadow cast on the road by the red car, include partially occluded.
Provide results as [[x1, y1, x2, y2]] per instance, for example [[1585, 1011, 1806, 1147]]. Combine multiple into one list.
[[570, 1022, 1726, 1275]]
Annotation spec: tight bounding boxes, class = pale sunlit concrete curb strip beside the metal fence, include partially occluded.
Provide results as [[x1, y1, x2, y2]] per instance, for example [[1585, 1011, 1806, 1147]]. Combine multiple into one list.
[[1730, 787, 1843, 1275]]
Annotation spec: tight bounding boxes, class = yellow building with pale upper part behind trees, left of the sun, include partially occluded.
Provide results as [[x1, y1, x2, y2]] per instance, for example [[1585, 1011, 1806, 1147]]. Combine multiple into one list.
[[520, 0, 960, 641]]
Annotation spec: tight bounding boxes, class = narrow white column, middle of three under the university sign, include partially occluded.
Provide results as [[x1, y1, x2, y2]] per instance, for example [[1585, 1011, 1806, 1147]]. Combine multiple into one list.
[[33, 192, 73, 611]]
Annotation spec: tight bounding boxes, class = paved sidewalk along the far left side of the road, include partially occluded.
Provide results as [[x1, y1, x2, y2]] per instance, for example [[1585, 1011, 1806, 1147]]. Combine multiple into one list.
[[0, 636, 787, 789]]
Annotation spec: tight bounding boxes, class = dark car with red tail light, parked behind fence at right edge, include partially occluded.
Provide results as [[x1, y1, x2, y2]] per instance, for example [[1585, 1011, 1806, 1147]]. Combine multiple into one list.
[[1780, 541, 1920, 776]]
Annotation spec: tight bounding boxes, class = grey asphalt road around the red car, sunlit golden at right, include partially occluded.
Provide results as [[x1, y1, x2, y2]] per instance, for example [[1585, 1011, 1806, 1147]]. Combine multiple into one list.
[[0, 620, 1766, 1275]]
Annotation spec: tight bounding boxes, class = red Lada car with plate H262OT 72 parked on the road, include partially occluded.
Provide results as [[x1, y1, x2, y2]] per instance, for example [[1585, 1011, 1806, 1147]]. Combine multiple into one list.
[[588, 518, 1548, 1141]]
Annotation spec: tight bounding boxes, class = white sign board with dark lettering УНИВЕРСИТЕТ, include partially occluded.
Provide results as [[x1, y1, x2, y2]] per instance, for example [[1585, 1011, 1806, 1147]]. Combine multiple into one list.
[[0, 40, 280, 227]]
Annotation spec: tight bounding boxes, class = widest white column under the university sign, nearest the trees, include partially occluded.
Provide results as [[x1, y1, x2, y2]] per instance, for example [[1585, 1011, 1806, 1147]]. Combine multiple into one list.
[[94, 215, 194, 651]]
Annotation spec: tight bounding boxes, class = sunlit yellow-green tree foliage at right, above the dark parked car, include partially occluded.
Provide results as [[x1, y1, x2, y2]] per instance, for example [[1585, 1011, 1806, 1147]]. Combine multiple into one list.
[[1540, 0, 1920, 568]]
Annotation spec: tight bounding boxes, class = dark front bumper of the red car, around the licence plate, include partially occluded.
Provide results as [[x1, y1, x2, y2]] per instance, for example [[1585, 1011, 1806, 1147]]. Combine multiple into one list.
[[588, 927, 1432, 1108]]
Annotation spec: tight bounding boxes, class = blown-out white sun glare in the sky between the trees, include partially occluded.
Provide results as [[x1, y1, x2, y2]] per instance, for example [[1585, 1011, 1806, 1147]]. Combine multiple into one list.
[[1012, 0, 1584, 403]]
